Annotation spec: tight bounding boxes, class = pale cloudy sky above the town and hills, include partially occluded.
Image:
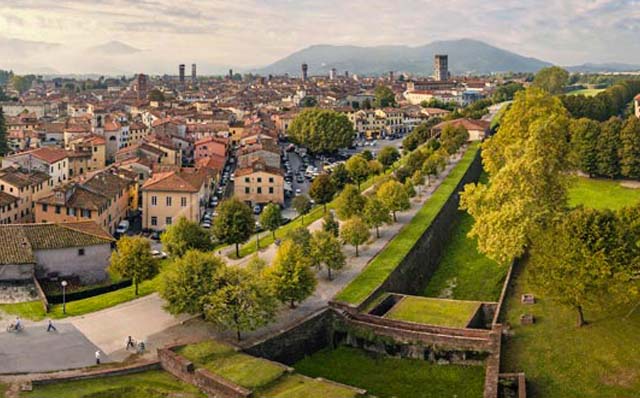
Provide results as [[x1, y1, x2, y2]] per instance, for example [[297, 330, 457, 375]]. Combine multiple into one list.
[[0, 0, 640, 74]]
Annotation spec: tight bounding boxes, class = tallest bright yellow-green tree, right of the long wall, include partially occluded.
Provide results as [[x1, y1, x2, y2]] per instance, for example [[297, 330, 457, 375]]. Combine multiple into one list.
[[460, 88, 571, 264]]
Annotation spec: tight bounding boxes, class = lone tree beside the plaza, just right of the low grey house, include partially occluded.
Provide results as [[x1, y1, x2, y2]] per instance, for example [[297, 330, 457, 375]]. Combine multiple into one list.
[[109, 236, 159, 296]]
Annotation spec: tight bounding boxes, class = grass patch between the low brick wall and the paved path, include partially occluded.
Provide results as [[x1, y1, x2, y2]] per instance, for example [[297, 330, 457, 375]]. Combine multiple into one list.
[[176, 340, 285, 389]]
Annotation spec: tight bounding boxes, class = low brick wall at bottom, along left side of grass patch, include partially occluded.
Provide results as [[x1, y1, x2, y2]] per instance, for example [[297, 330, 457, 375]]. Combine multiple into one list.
[[158, 348, 253, 398]]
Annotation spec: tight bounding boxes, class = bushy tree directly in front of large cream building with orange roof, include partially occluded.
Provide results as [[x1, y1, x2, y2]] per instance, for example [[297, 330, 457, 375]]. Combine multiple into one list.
[[160, 217, 213, 257]]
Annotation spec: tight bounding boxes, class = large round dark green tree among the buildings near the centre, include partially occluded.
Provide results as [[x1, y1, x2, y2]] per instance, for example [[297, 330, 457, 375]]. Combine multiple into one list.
[[287, 108, 355, 153]]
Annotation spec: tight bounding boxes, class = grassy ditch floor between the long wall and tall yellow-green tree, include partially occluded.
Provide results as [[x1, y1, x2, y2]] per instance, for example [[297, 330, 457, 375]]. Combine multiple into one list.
[[424, 211, 508, 301]]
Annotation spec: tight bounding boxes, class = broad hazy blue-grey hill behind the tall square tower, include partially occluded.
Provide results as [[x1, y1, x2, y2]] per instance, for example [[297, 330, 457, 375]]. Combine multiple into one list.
[[254, 39, 551, 76]]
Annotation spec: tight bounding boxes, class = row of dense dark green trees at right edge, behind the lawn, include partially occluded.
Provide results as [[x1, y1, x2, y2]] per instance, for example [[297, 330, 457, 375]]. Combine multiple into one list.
[[570, 116, 640, 179]]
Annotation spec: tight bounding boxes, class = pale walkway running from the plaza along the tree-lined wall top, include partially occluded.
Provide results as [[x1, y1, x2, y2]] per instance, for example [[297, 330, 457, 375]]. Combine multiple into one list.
[[0, 146, 461, 373]]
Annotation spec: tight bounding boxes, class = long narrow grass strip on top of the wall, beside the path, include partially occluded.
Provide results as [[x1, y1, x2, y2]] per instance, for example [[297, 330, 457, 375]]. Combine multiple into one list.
[[336, 143, 478, 304]]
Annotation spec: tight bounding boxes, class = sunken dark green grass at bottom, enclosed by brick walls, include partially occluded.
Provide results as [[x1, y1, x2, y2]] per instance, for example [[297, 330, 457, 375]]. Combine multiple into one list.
[[294, 347, 484, 398]]
